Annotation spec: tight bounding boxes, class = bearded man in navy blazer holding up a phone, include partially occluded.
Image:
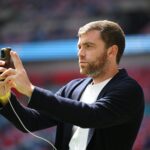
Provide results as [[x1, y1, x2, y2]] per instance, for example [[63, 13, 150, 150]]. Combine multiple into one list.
[[0, 20, 144, 150]]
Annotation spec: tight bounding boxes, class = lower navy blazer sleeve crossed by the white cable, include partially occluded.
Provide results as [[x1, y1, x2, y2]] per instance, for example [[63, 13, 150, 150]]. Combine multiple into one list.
[[0, 95, 57, 132]]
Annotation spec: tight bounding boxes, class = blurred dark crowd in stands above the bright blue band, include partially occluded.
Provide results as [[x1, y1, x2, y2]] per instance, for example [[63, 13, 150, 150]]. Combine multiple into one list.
[[0, 0, 150, 43]]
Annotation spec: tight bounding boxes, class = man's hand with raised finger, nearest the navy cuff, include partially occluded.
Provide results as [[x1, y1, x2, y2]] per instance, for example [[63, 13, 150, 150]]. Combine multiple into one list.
[[0, 51, 34, 97]]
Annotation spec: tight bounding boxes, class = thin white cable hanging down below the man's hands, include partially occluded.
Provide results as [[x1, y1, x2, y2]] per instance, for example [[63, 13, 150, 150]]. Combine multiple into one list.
[[9, 99, 57, 150]]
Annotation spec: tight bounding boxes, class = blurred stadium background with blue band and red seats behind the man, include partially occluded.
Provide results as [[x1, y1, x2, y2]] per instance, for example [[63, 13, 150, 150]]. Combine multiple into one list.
[[0, 0, 150, 150]]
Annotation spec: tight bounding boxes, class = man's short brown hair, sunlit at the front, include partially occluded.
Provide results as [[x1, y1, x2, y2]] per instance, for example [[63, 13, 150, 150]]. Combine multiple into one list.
[[78, 20, 125, 64]]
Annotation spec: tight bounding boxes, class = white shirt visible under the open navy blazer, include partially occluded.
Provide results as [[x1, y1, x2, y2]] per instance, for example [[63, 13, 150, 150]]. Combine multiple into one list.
[[69, 79, 111, 150]]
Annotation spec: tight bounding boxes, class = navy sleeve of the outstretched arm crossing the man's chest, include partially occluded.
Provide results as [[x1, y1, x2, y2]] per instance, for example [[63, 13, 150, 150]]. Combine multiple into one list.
[[29, 78, 144, 128]]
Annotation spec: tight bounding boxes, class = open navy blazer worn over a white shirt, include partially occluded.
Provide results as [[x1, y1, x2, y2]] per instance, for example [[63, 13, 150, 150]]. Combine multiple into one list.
[[0, 69, 144, 150]]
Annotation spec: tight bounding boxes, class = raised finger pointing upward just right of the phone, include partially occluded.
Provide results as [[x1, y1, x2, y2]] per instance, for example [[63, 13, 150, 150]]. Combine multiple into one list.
[[10, 51, 24, 70]]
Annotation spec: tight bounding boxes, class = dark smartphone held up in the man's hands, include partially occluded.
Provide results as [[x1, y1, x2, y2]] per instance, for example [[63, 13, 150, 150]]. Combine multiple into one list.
[[1, 47, 11, 68]]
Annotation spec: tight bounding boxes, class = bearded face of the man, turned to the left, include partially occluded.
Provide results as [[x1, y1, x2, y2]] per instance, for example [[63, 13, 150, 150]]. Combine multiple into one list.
[[78, 30, 108, 77]]
